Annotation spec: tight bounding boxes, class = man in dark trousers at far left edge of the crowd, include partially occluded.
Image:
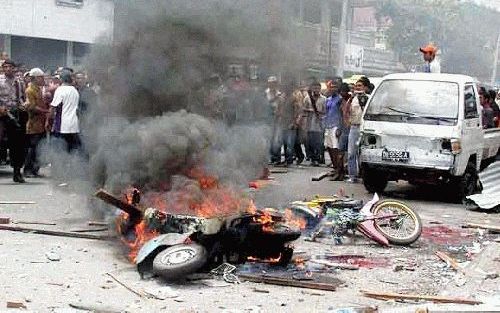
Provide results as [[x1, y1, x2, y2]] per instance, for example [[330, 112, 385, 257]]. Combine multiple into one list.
[[0, 60, 27, 183]]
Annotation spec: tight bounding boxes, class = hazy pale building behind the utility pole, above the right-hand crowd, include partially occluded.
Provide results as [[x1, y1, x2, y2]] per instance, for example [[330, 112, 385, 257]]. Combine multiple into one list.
[[292, 0, 405, 77]]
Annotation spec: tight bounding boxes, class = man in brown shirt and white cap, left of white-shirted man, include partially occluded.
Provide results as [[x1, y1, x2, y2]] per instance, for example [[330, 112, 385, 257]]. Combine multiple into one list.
[[24, 68, 49, 177]]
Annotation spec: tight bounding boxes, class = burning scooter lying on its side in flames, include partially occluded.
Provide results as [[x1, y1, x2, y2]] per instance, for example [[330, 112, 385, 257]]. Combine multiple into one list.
[[96, 190, 301, 280]]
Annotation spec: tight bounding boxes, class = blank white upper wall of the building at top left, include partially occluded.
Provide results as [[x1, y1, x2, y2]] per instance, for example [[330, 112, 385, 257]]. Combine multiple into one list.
[[0, 0, 114, 43]]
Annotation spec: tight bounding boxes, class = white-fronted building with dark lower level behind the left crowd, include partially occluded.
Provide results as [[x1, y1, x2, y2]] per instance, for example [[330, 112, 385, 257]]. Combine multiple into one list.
[[0, 0, 114, 69]]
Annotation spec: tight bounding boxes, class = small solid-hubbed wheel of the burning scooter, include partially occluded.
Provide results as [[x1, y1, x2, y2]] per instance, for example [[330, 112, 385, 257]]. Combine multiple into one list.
[[153, 243, 207, 280]]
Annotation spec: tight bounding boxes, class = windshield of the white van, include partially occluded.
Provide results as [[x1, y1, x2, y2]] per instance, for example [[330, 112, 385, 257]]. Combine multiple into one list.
[[365, 80, 459, 125]]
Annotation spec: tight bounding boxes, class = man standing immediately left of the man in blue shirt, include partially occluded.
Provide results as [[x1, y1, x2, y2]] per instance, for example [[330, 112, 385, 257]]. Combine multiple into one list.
[[303, 81, 326, 167]]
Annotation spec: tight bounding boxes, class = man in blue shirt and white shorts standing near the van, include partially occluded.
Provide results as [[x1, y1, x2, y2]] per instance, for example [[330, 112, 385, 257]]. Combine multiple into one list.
[[325, 78, 343, 180]]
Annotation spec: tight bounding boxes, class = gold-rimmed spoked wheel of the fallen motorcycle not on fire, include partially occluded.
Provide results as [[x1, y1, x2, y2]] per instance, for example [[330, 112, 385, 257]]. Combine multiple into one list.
[[372, 200, 422, 245]]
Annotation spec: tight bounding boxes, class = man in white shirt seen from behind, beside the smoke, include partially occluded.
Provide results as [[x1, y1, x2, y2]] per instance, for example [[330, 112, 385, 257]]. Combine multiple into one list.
[[45, 71, 81, 152]]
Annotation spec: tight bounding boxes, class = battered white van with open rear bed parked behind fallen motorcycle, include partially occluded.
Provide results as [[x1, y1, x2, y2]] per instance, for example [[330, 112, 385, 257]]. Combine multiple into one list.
[[360, 73, 500, 199]]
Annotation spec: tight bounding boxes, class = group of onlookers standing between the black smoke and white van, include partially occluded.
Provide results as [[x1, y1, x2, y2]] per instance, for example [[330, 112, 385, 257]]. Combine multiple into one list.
[[266, 76, 374, 183]]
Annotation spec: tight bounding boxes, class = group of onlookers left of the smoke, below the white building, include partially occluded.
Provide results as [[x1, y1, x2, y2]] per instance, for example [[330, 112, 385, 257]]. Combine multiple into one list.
[[0, 53, 94, 183]]
